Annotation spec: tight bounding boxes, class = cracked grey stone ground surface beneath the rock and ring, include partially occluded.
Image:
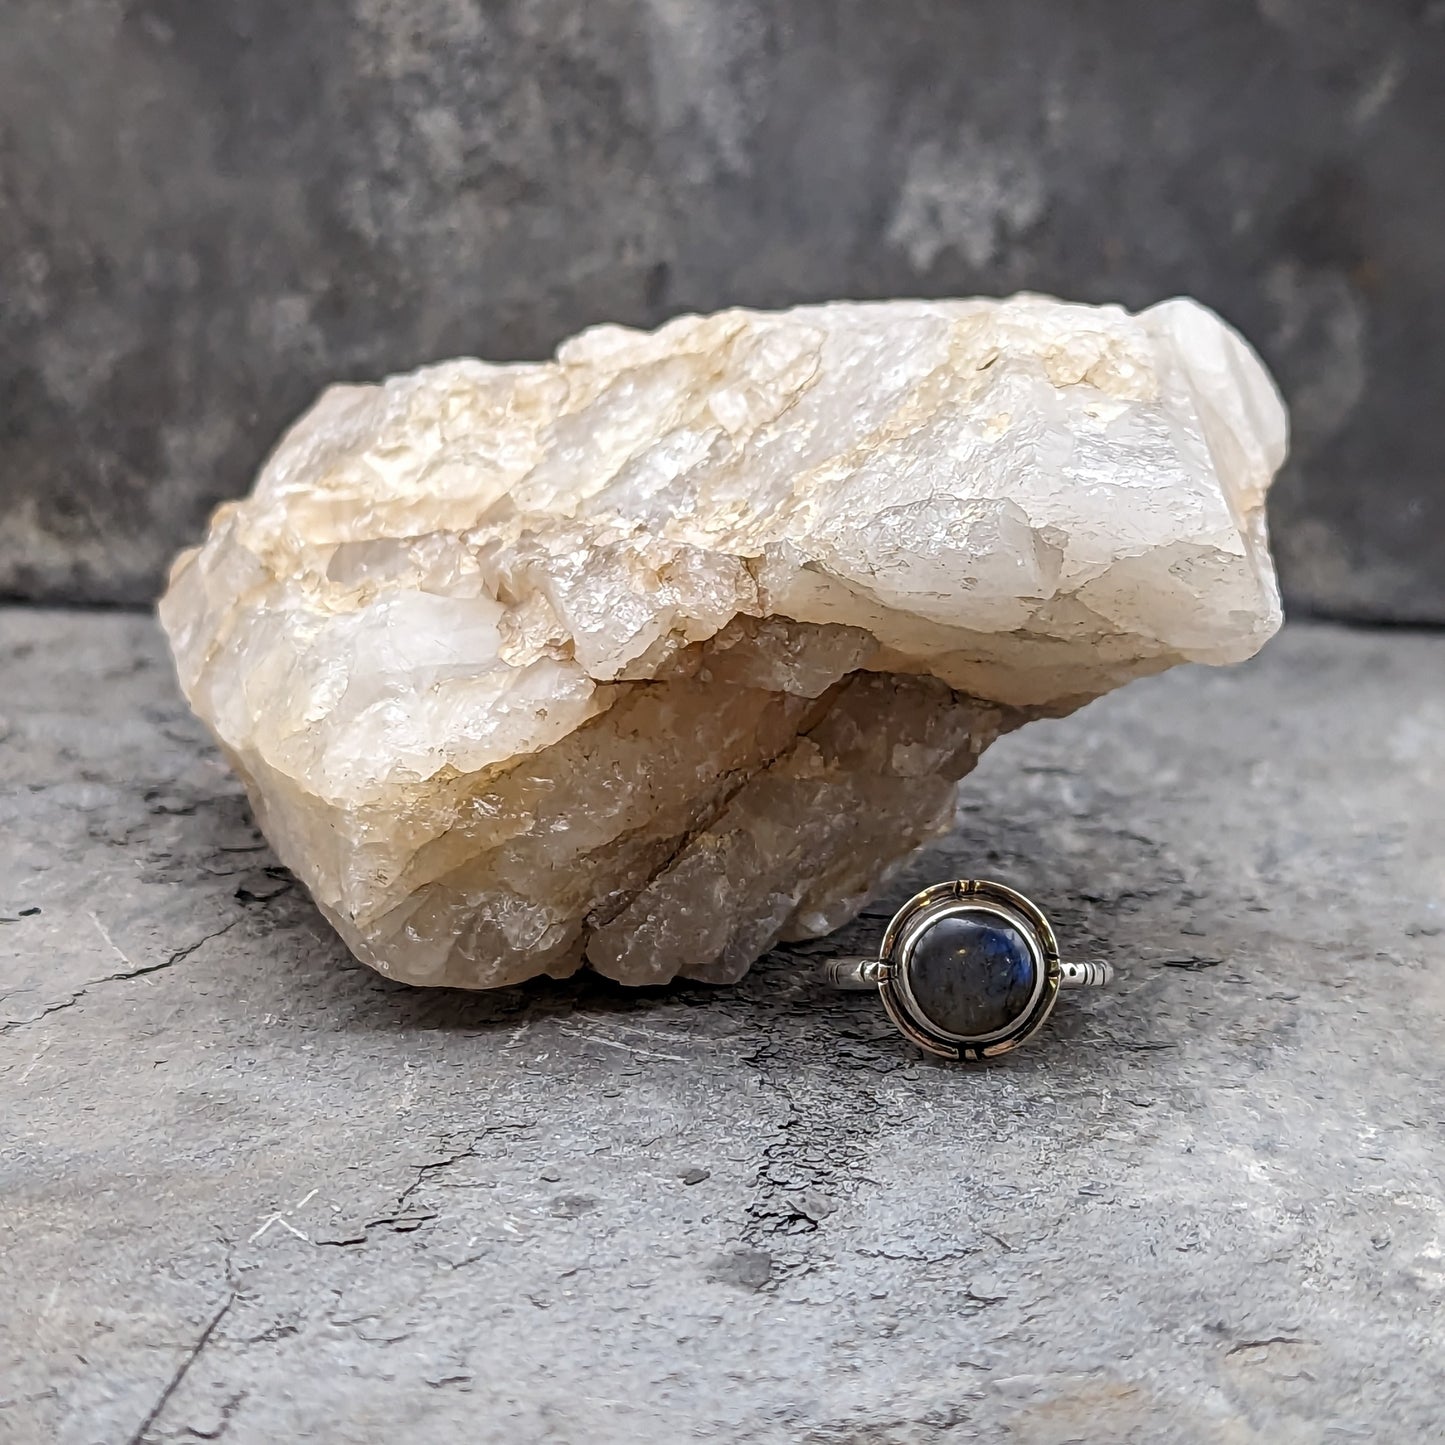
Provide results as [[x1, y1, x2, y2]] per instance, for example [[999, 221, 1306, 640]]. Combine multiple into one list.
[[0, 610, 1445, 1445]]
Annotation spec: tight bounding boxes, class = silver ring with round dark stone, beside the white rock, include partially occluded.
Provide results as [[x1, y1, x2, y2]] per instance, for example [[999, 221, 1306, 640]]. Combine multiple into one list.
[[828, 879, 1114, 1059]]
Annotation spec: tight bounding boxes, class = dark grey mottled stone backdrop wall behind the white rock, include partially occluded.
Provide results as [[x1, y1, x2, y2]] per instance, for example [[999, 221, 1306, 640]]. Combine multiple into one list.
[[0, 0, 1445, 623]]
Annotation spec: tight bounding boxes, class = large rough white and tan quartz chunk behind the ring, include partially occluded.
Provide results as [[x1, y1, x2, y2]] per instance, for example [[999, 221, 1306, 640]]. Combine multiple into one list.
[[160, 296, 1286, 988]]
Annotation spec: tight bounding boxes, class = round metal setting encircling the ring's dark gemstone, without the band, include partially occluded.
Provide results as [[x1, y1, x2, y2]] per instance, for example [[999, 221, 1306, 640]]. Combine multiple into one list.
[[879, 879, 1062, 1059]]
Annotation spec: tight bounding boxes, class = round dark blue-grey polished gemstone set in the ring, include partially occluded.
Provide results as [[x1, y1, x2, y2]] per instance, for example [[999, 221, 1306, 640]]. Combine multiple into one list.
[[907, 913, 1039, 1039]]
